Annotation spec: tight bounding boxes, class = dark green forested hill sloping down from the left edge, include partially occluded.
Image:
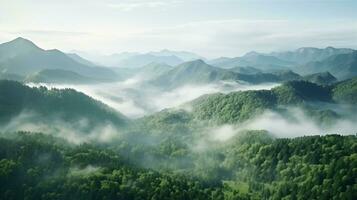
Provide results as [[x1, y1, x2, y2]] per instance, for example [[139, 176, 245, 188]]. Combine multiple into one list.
[[0, 80, 127, 127]]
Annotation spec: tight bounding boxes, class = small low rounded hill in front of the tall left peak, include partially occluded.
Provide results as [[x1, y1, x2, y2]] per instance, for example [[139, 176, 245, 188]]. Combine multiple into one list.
[[25, 69, 98, 84]]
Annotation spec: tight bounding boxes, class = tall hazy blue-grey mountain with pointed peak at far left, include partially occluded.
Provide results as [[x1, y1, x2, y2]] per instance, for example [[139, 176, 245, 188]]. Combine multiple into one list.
[[0, 38, 118, 81]]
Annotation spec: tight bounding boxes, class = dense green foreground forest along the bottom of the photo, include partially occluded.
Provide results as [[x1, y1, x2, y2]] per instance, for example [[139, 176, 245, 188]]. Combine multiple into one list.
[[0, 133, 357, 200]]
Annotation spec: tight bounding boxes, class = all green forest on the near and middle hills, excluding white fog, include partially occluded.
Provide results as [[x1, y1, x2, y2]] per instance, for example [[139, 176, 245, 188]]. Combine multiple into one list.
[[0, 79, 357, 199]]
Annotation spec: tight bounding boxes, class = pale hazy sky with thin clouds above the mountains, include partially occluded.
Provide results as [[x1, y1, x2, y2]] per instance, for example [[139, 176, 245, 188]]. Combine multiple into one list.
[[0, 0, 357, 57]]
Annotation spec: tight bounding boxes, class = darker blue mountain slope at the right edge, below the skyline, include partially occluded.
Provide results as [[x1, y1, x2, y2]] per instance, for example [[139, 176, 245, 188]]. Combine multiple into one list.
[[294, 51, 357, 80]]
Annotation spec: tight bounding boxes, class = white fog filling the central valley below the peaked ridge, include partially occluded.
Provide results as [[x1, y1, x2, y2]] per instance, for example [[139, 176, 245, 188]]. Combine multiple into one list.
[[28, 77, 278, 118]]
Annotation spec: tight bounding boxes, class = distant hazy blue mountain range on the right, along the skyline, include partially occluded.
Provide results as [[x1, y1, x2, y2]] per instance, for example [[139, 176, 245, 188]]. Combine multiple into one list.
[[208, 47, 357, 80]]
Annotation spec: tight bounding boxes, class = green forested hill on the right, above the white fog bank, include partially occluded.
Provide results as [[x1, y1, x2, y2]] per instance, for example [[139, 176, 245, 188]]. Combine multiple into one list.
[[189, 78, 357, 123]]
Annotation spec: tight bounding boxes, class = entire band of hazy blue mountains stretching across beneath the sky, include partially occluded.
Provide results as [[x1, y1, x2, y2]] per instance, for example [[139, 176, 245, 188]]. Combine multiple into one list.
[[0, 38, 357, 85]]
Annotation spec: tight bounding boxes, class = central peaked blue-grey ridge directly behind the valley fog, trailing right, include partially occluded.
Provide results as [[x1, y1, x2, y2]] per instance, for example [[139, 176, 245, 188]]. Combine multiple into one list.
[[148, 60, 337, 89]]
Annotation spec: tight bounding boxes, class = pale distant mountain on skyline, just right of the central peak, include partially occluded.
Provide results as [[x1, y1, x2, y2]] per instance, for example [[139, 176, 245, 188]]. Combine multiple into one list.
[[208, 52, 293, 71]]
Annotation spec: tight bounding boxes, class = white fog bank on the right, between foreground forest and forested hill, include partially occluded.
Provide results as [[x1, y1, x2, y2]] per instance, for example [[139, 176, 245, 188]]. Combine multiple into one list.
[[205, 105, 357, 142]]
